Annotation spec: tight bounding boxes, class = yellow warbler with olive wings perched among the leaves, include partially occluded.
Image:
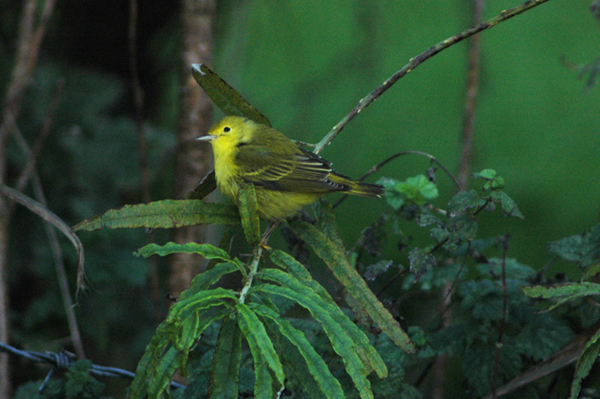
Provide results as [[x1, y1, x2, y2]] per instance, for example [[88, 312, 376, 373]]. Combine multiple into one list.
[[198, 116, 383, 221]]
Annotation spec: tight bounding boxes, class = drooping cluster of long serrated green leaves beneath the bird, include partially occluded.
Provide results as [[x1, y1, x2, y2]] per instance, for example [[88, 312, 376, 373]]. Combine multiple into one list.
[[119, 185, 415, 398]]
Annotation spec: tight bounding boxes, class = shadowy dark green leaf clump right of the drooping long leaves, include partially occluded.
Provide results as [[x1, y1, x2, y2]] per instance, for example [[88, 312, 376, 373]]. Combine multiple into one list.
[[430, 258, 574, 395]]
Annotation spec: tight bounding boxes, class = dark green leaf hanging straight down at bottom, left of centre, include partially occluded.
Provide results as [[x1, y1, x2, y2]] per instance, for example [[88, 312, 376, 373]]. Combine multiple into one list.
[[209, 319, 242, 399]]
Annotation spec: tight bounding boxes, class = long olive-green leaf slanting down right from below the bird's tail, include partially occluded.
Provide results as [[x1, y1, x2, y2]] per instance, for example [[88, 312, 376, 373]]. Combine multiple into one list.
[[290, 220, 416, 353]]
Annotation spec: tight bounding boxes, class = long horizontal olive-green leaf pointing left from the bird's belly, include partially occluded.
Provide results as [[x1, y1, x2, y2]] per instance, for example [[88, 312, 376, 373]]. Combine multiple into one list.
[[73, 200, 240, 231]]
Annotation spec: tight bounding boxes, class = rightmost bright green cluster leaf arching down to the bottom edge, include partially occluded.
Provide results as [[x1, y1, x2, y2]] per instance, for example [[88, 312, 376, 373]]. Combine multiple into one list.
[[253, 282, 373, 398]]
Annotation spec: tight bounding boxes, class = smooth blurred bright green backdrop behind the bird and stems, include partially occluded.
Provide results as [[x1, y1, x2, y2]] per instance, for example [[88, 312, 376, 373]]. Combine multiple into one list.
[[215, 0, 600, 276]]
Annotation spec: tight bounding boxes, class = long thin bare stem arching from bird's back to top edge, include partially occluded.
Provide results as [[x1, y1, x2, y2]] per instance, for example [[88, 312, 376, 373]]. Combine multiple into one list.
[[314, 0, 549, 154]]
